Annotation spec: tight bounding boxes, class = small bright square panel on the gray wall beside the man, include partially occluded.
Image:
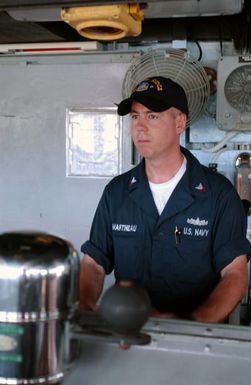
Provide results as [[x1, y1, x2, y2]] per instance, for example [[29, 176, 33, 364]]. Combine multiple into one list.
[[66, 108, 121, 177]]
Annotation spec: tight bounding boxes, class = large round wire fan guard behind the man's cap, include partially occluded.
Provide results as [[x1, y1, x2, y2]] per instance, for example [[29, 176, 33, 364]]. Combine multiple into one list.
[[122, 49, 210, 126]]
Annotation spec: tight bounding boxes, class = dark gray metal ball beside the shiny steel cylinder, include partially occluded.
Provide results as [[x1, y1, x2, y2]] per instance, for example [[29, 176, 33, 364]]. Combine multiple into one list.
[[99, 281, 151, 335]]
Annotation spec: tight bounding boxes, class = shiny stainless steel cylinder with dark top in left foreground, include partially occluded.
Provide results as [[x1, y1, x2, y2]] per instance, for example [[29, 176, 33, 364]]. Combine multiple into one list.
[[0, 232, 79, 385]]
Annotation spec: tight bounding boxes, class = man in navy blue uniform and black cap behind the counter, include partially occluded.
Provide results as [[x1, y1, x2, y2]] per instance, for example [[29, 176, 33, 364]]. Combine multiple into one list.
[[80, 76, 251, 322]]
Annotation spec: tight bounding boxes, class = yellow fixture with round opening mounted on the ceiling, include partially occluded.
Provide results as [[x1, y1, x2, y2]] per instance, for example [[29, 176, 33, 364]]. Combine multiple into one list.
[[61, 4, 144, 40]]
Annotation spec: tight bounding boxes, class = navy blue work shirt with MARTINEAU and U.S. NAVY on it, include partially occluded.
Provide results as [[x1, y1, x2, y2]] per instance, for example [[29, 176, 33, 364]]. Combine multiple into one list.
[[81, 147, 251, 314]]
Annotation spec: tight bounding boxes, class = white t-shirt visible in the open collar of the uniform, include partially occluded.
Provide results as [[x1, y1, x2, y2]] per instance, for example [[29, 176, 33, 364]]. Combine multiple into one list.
[[149, 157, 187, 215]]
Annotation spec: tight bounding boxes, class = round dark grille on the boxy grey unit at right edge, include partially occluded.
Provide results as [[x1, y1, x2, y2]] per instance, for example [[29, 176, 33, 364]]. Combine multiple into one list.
[[224, 64, 251, 112]]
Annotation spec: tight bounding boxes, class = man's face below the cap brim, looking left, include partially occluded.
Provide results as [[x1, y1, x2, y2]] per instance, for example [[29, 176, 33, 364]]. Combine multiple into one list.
[[130, 102, 186, 160]]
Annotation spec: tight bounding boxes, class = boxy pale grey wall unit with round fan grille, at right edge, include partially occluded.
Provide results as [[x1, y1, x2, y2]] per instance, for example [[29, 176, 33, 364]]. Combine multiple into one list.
[[216, 56, 251, 131]]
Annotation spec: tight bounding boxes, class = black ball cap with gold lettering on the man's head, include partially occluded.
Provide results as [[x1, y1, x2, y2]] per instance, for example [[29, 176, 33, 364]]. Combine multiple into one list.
[[118, 76, 189, 117]]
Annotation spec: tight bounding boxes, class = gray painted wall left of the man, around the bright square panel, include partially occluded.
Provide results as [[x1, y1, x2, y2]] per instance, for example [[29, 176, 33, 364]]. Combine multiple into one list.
[[0, 54, 134, 255]]
